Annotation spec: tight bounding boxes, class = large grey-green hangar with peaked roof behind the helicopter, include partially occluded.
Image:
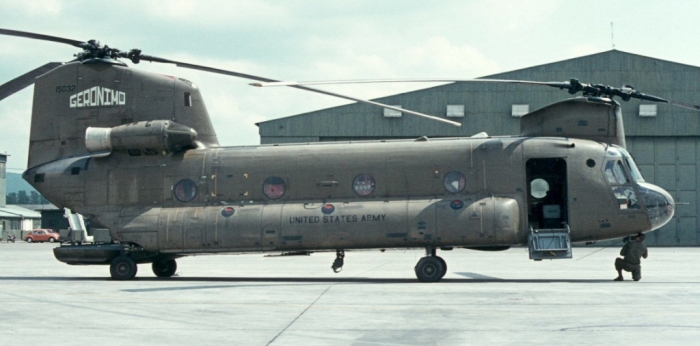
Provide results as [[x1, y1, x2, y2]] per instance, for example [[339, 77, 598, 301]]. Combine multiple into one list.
[[257, 50, 700, 246]]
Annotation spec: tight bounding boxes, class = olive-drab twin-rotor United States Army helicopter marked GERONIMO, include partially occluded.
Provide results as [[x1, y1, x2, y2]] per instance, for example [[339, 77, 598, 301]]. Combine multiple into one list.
[[0, 29, 684, 282]]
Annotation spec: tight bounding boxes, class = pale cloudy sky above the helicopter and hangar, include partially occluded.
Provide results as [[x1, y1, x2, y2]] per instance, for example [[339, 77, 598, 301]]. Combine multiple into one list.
[[0, 0, 700, 172]]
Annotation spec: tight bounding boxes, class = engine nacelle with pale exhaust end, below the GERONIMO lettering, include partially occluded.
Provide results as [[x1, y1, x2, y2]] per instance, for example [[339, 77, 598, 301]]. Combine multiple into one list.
[[85, 120, 197, 153]]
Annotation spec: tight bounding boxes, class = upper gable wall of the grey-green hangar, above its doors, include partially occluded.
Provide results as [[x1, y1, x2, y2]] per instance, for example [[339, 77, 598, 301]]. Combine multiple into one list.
[[258, 50, 700, 144]]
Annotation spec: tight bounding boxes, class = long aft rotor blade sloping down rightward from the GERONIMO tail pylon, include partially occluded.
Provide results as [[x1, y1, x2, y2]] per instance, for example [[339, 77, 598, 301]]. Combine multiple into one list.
[[139, 55, 462, 126]]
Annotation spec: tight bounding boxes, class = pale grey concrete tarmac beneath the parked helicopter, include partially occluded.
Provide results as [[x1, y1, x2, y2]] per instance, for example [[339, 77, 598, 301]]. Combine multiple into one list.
[[0, 242, 700, 346]]
